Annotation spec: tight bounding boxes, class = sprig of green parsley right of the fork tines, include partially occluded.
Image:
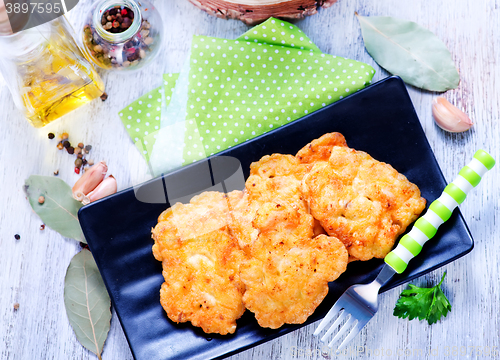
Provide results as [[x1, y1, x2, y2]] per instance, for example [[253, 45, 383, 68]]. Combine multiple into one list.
[[393, 272, 451, 325]]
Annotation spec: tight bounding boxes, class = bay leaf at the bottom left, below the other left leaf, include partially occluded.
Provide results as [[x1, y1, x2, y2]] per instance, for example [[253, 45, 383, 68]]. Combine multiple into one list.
[[64, 249, 111, 359]]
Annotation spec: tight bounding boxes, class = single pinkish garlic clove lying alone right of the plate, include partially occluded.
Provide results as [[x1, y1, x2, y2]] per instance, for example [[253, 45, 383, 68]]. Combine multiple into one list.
[[432, 96, 473, 132]]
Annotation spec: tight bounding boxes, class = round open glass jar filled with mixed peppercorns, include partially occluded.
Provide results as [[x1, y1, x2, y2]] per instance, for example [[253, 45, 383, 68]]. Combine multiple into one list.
[[82, 0, 163, 70]]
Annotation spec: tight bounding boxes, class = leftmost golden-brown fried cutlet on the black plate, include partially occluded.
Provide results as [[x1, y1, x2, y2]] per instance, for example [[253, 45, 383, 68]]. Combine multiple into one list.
[[152, 192, 245, 335]]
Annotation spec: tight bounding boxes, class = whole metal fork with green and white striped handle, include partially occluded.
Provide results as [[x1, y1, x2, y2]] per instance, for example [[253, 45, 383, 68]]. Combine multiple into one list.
[[313, 150, 495, 349]]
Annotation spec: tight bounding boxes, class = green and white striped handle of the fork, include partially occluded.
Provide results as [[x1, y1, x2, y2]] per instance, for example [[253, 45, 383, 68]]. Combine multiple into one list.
[[384, 150, 495, 274]]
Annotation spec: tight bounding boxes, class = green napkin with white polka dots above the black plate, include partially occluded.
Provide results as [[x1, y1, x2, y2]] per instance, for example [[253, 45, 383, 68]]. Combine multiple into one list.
[[121, 18, 374, 174]]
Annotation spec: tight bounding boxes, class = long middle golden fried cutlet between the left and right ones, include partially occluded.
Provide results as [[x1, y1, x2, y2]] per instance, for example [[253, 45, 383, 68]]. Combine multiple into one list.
[[228, 154, 348, 329]]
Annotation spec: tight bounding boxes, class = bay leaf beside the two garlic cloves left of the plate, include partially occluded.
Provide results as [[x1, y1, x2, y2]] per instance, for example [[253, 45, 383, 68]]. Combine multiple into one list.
[[25, 175, 86, 243]]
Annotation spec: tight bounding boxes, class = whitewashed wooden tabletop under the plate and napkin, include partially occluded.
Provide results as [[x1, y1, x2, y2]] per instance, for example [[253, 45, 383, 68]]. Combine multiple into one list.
[[0, 0, 500, 360]]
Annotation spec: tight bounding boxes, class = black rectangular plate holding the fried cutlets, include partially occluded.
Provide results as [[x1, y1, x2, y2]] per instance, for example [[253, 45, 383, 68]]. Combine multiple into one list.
[[79, 77, 473, 360]]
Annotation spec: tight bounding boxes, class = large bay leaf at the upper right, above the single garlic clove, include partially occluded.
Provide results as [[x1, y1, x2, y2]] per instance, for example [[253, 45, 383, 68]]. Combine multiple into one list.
[[356, 14, 460, 91]]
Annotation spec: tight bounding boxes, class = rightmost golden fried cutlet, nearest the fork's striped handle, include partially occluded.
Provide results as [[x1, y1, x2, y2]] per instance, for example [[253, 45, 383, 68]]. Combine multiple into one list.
[[301, 146, 426, 260]]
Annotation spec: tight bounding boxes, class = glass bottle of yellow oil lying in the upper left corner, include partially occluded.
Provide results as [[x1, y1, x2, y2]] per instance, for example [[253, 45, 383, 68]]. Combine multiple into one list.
[[0, 16, 104, 127]]
